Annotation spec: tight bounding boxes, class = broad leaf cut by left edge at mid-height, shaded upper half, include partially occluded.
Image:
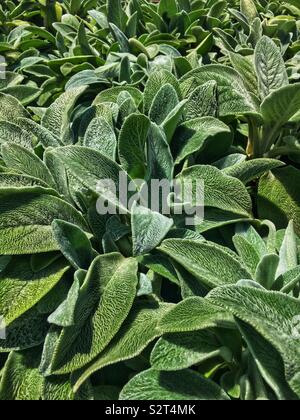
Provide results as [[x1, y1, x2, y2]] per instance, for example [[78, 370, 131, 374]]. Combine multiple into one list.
[[0, 188, 88, 255]]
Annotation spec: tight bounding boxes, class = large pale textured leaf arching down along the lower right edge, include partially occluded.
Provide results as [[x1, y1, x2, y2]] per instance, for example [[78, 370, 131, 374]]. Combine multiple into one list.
[[209, 286, 300, 396]]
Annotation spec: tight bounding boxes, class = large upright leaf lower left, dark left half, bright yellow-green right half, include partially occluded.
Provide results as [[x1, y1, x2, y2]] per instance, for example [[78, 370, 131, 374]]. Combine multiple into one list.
[[43, 254, 138, 375]]
